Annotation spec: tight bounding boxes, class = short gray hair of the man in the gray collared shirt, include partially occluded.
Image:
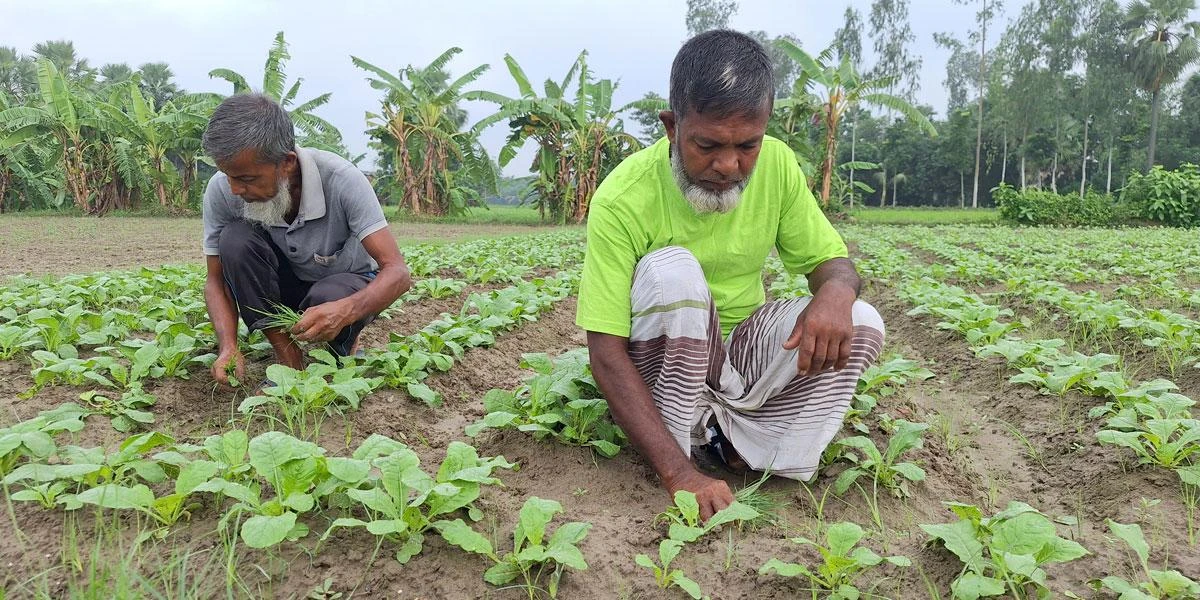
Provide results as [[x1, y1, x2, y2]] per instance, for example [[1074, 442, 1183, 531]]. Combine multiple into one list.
[[204, 94, 296, 164]]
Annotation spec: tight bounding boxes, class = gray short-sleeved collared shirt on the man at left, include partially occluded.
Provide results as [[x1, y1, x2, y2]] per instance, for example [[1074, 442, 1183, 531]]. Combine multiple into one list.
[[204, 146, 388, 281]]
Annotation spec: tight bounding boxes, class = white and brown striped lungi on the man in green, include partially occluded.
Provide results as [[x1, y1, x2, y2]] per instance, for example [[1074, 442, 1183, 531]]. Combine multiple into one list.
[[629, 246, 883, 481]]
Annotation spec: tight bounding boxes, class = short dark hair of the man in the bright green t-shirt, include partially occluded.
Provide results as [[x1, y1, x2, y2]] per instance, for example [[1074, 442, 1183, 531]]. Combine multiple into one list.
[[670, 29, 775, 120]]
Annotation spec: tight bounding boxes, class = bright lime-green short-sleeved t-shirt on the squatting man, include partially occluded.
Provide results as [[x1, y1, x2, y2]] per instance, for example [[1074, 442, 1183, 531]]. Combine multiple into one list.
[[575, 137, 848, 337]]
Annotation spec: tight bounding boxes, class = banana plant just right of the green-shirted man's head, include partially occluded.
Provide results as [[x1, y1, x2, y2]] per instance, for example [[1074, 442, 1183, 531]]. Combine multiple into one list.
[[775, 38, 937, 206]]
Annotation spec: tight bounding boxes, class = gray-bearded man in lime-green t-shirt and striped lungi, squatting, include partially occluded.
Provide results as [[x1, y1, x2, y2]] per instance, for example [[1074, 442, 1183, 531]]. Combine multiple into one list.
[[576, 30, 883, 518]]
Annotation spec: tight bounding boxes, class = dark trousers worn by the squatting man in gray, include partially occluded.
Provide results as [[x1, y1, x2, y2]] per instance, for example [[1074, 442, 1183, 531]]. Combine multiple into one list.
[[217, 221, 374, 356]]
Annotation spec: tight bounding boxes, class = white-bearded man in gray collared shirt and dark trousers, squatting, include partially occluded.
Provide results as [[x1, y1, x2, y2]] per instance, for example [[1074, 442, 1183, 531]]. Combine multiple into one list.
[[204, 95, 412, 383]]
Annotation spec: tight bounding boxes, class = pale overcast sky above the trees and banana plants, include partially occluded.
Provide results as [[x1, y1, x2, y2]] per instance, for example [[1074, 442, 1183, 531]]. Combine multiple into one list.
[[0, 0, 1027, 175]]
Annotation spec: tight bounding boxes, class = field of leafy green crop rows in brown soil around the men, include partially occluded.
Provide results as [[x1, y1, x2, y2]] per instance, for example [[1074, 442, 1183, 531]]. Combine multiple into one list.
[[0, 223, 1200, 599]]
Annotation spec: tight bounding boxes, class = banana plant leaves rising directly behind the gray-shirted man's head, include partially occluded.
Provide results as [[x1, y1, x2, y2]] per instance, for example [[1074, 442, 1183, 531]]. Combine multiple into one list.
[[209, 31, 344, 152]]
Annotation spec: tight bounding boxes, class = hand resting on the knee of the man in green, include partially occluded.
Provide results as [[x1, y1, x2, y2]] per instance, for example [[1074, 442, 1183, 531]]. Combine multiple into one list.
[[784, 282, 856, 376]]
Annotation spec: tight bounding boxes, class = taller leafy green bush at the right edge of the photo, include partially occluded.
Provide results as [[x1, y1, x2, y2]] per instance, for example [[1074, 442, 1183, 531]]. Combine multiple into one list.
[[1121, 163, 1200, 227]]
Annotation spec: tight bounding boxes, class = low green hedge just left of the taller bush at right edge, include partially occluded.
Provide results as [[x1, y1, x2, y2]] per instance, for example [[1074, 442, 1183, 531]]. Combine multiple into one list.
[[991, 184, 1130, 227]]
